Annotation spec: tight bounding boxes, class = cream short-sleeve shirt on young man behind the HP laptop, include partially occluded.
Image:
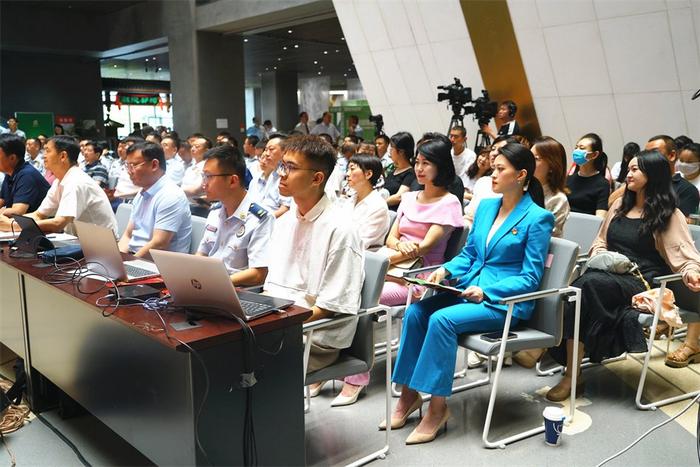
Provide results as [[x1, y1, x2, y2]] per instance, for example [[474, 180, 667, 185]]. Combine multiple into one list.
[[264, 195, 364, 349]]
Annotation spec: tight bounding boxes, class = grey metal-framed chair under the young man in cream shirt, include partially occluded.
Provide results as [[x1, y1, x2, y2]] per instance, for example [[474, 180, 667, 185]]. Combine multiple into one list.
[[303, 251, 392, 466]]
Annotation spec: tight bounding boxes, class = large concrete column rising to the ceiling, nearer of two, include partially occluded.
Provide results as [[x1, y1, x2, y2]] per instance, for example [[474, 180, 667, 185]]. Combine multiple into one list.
[[168, 0, 248, 138]]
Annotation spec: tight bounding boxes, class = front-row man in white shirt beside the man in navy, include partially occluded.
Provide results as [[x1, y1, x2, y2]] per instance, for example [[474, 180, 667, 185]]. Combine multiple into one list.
[[0, 136, 117, 236]]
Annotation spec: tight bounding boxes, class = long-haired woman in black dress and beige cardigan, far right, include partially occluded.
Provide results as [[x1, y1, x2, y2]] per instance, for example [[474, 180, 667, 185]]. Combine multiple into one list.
[[547, 151, 700, 401]]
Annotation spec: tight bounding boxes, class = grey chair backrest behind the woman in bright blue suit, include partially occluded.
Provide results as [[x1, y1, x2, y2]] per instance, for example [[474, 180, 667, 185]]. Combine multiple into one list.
[[527, 238, 580, 342]]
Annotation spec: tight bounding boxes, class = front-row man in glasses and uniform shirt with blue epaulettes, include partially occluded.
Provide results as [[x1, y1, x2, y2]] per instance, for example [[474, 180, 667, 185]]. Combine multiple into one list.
[[197, 145, 275, 285]]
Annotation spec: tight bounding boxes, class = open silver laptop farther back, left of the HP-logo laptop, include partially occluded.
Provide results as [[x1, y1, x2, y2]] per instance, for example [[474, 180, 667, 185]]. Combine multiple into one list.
[[73, 221, 159, 282]]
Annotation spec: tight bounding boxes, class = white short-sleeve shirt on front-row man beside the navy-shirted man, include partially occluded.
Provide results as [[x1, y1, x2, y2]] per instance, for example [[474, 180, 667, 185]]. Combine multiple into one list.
[[37, 166, 117, 235]]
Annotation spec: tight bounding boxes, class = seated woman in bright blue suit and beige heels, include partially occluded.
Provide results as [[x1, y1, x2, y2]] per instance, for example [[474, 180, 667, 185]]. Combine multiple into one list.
[[380, 143, 554, 444]]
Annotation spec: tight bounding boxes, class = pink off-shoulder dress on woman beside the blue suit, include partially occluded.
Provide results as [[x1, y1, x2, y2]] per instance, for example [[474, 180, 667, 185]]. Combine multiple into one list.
[[379, 191, 464, 306]]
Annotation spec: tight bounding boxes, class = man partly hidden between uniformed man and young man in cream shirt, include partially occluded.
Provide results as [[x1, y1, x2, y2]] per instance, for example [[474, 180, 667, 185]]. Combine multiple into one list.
[[248, 133, 291, 217]]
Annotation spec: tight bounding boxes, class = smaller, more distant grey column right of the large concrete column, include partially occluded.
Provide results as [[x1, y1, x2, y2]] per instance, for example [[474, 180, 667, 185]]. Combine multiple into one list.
[[259, 71, 299, 131]]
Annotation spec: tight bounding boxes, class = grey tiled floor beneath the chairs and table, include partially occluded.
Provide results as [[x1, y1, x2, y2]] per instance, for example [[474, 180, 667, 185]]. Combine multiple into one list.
[[0, 343, 700, 467]]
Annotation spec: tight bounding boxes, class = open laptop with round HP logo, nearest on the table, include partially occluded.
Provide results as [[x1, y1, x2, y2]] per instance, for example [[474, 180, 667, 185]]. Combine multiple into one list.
[[151, 250, 294, 321]]
